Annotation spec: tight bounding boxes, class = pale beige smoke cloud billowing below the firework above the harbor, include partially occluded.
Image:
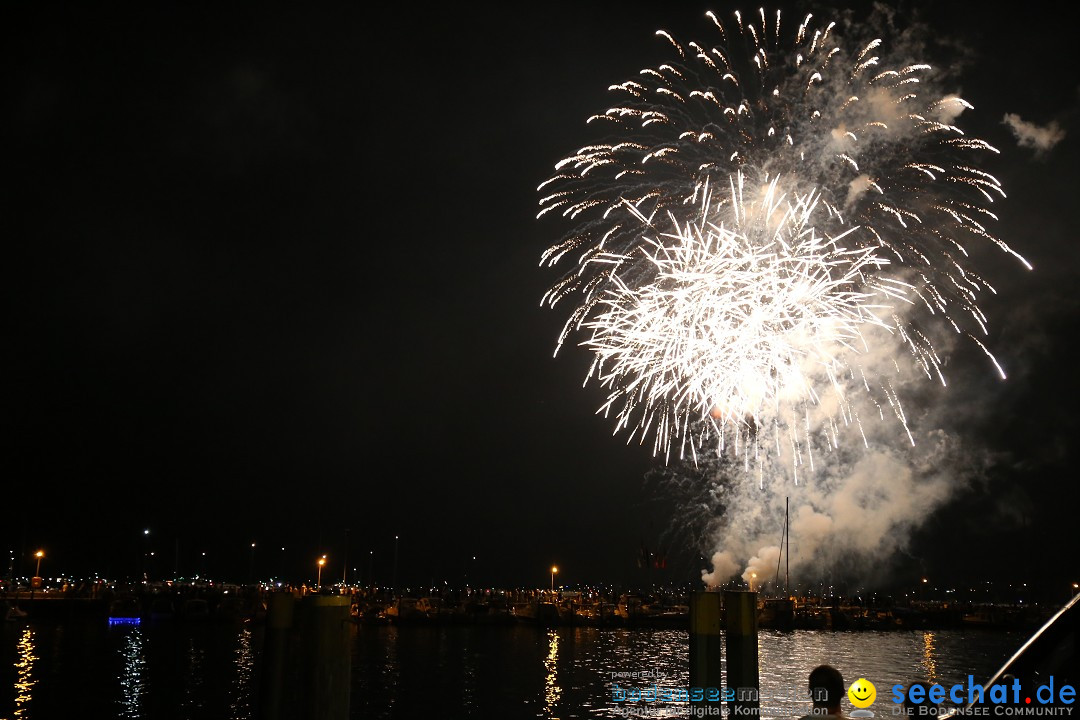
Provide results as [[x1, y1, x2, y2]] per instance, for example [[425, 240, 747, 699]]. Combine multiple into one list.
[[703, 313, 988, 590]]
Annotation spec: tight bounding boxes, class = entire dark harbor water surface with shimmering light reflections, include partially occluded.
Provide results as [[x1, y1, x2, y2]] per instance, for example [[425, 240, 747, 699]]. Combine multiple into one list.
[[0, 622, 1024, 720]]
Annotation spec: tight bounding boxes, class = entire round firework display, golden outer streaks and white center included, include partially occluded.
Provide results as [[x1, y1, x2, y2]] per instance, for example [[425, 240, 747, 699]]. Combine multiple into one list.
[[538, 10, 1029, 468]]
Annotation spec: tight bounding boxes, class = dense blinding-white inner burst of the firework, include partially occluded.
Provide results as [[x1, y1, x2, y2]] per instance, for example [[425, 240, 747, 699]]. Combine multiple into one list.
[[584, 181, 907, 464]]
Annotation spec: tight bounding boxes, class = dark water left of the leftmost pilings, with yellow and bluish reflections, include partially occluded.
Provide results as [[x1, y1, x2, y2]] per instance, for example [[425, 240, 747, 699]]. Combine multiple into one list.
[[0, 621, 261, 720]]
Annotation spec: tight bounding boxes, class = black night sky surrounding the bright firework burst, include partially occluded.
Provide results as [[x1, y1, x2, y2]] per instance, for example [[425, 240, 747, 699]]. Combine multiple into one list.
[[8, 3, 1080, 595]]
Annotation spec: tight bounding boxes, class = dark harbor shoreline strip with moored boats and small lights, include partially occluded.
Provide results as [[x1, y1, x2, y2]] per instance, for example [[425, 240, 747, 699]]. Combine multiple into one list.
[[0, 581, 1056, 630]]
